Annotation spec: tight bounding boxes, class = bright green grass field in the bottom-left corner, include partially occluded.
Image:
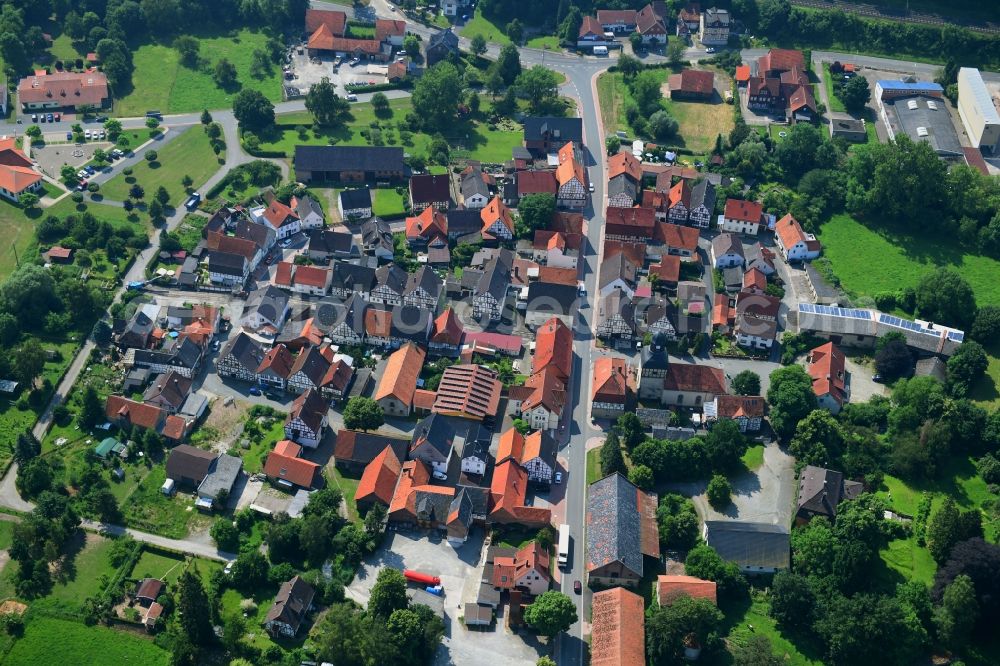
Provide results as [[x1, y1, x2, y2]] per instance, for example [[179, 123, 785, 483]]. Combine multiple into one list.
[[4, 617, 170, 666]]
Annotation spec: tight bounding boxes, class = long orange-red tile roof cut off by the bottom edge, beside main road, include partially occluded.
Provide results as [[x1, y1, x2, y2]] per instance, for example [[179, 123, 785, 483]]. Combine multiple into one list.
[[590, 587, 646, 666]]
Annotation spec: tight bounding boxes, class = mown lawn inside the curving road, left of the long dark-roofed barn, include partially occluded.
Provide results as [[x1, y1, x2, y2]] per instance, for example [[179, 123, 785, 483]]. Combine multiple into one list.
[[101, 127, 219, 206]]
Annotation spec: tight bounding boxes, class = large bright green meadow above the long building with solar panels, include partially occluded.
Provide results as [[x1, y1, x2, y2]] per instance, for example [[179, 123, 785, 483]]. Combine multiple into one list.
[[819, 213, 1000, 306]]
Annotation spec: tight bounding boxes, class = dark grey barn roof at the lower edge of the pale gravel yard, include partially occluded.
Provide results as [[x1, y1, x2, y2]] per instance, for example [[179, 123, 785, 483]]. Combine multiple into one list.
[[705, 520, 791, 569]]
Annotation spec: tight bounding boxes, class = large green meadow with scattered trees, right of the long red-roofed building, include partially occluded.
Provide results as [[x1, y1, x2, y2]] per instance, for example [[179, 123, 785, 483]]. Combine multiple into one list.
[[114, 30, 281, 116]]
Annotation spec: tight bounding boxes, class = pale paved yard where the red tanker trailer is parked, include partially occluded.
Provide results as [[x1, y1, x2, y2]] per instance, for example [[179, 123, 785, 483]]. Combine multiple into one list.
[[346, 529, 542, 666]]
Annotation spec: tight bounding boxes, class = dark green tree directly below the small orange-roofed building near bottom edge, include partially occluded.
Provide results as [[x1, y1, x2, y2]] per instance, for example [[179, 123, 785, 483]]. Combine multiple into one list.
[[646, 596, 723, 666]]
